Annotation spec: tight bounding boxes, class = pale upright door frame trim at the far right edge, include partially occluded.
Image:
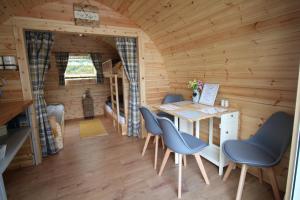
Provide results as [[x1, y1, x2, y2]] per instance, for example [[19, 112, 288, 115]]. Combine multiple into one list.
[[284, 65, 300, 200]]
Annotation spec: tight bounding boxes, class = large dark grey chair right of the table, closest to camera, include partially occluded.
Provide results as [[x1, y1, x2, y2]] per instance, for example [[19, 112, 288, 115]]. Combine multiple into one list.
[[223, 112, 293, 200]]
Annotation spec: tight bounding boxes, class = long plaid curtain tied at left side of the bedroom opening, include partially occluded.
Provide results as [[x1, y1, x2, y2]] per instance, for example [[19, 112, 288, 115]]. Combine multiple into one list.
[[25, 31, 57, 156]]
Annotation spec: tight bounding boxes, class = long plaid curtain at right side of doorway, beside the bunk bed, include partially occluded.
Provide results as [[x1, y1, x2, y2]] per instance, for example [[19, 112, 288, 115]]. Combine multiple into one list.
[[115, 37, 140, 136]]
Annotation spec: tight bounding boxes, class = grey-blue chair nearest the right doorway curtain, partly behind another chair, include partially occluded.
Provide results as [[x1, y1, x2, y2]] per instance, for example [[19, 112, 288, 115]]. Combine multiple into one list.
[[140, 106, 164, 169]]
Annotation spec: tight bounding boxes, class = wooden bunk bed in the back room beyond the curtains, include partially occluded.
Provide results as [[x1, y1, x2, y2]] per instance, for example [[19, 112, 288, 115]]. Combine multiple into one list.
[[102, 60, 129, 135]]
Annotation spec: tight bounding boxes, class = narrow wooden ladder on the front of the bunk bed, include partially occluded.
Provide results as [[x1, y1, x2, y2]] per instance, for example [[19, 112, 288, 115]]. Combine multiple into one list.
[[109, 74, 120, 133]]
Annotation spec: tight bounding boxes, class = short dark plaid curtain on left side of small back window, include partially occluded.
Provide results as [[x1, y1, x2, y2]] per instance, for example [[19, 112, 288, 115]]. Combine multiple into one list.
[[55, 52, 69, 85]]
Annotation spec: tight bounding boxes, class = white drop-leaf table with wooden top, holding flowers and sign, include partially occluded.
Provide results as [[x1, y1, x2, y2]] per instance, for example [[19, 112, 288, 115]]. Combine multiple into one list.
[[155, 101, 239, 176]]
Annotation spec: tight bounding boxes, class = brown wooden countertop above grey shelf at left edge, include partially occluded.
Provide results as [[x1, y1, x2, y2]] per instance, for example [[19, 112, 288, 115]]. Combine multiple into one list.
[[0, 100, 32, 125]]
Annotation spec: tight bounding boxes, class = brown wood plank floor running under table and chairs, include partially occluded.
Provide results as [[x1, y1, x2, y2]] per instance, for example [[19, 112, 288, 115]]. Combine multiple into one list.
[[4, 118, 273, 200]]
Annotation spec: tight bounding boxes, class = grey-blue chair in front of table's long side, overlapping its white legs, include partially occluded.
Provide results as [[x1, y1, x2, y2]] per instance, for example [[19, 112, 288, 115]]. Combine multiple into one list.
[[158, 117, 209, 198]]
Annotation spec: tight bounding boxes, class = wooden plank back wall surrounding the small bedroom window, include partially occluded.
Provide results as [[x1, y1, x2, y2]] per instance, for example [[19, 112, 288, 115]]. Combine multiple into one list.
[[45, 33, 118, 120]]
